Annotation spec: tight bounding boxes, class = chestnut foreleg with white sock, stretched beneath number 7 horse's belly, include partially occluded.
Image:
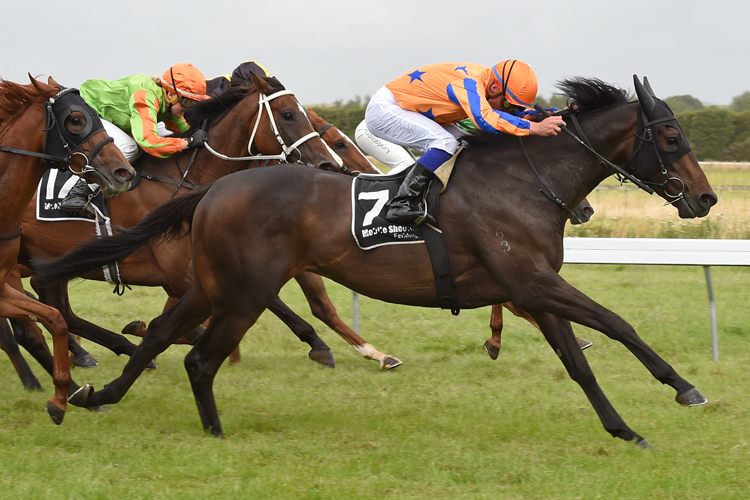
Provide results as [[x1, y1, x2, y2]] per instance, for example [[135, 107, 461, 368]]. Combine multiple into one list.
[[294, 273, 402, 370]]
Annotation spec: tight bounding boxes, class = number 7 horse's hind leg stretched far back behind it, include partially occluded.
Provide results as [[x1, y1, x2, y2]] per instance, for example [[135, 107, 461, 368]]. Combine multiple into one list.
[[86, 285, 211, 406]]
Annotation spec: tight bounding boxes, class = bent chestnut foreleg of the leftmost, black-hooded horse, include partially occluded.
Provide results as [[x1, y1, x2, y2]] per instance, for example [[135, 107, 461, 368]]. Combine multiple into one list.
[[0, 283, 71, 424]]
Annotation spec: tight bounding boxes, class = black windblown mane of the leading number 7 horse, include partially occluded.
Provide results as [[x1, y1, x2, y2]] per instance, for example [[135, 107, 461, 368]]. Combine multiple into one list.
[[462, 77, 630, 146]]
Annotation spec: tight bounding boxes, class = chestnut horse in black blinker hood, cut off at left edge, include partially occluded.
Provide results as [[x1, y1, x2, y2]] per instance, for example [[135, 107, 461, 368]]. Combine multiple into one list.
[[0, 76, 135, 424]]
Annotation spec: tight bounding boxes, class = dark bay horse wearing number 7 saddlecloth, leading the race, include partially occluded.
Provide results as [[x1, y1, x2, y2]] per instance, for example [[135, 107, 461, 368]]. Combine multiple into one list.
[[32, 78, 717, 447]]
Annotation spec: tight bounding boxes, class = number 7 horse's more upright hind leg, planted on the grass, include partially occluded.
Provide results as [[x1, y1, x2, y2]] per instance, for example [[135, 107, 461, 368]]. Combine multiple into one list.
[[185, 307, 260, 436]]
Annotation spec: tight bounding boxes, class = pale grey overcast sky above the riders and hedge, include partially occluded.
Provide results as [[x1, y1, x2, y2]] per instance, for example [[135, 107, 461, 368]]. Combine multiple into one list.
[[0, 0, 750, 105]]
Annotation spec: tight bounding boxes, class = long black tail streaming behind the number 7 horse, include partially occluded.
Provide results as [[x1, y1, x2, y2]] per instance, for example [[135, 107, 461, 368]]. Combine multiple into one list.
[[31, 186, 208, 287]]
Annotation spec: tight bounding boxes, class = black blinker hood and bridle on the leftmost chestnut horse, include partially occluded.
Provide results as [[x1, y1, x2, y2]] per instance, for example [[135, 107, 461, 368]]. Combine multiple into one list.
[[0, 87, 114, 177]]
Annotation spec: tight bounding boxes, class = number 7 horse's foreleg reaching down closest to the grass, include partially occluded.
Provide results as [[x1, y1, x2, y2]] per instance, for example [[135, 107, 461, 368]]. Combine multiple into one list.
[[536, 313, 650, 448]]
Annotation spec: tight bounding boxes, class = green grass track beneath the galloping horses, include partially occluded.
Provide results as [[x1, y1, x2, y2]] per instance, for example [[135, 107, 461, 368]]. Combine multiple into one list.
[[0, 266, 750, 500]]
